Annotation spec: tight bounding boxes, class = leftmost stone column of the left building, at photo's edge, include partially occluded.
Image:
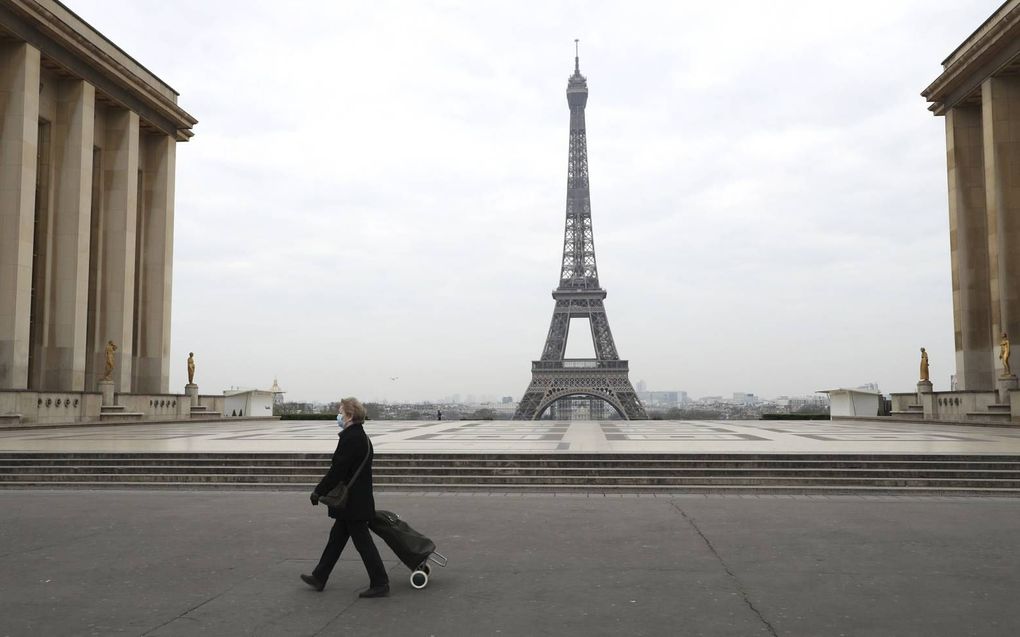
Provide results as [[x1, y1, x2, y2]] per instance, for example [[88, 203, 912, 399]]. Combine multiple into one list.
[[0, 41, 40, 389]]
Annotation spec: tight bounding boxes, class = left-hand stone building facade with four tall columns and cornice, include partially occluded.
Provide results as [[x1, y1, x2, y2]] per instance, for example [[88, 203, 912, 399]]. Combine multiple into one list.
[[0, 0, 197, 397]]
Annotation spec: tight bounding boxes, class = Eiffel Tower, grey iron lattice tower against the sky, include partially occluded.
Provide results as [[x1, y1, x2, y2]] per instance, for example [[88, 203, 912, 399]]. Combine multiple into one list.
[[514, 45, 648, 420]]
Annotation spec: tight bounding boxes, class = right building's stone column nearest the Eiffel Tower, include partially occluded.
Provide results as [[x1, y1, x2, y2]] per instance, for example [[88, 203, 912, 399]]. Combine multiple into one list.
[[946, 105, 995, 390]]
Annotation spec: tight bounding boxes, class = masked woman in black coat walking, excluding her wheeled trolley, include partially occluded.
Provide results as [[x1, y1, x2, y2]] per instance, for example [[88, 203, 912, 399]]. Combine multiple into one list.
[[301, 397, 390, 597]]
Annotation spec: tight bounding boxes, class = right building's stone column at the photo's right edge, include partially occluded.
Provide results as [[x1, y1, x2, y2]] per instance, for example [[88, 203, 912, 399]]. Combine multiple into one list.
[[981, 76, 1020, 375]]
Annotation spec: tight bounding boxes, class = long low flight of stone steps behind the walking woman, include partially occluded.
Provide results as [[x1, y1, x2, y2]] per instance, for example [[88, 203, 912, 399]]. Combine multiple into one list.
[[0, 453, 1020, 496]]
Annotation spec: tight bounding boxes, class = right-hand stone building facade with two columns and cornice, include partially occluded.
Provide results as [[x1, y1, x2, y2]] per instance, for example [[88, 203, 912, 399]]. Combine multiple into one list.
[[922, 0, 1020, 390]]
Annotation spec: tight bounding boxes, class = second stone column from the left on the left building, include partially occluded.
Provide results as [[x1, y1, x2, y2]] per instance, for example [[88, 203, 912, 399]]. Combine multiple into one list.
[[42, 79, 96, 391]]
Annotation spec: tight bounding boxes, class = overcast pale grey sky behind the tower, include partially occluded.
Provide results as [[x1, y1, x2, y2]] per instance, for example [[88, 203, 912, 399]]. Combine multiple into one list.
[[73, 0, 1000, 401]]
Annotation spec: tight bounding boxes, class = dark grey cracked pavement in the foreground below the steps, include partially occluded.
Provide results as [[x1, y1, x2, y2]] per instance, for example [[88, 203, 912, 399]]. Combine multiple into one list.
[[0, 490, 1020, 637]]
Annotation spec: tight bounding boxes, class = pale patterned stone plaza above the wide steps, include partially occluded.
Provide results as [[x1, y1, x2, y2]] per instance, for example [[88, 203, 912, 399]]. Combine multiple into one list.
[[0, 420, 1020, 455]]
